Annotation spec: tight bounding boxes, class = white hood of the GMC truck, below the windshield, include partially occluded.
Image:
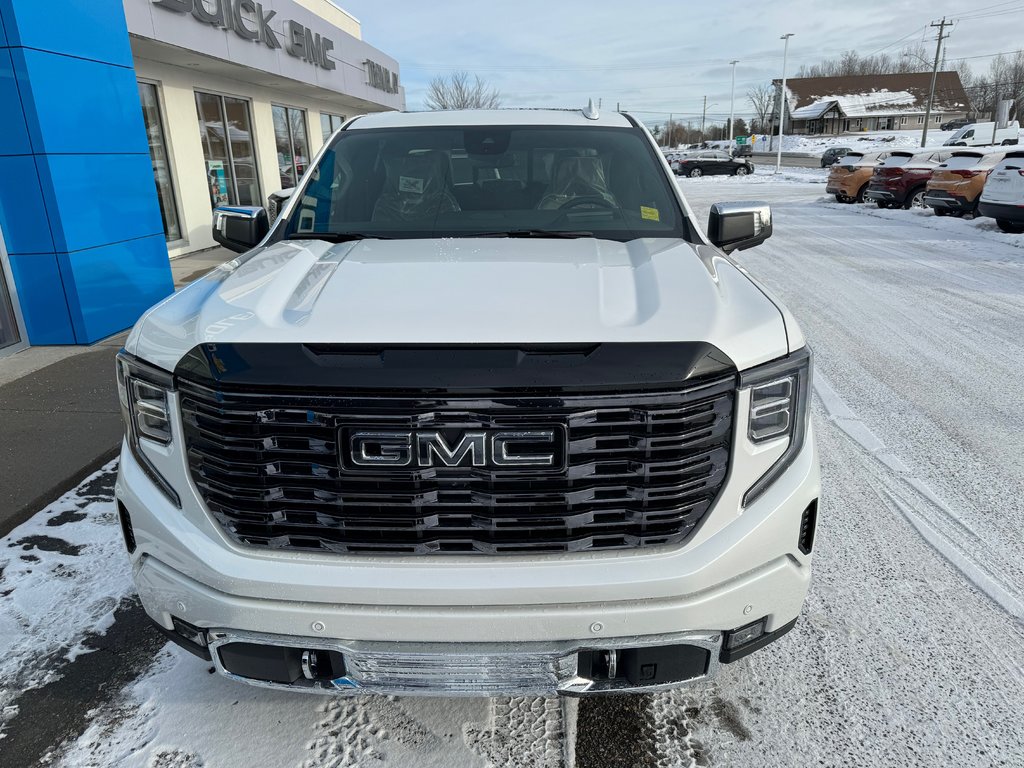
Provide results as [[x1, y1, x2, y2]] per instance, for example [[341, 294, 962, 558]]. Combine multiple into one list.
[[125, 238, 790, 371]]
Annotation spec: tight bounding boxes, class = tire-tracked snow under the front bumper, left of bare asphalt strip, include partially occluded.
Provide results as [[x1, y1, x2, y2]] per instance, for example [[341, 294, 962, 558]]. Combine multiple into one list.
[[59, 644, 566, 768]]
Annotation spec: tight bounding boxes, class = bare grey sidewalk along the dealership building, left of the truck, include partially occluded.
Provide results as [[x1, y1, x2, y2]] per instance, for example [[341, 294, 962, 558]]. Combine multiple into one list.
[[0, 248, 234, 536]]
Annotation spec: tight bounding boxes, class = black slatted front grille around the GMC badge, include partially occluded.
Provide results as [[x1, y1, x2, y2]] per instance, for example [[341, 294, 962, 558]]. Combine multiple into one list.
[[178, 376, 735, 554]]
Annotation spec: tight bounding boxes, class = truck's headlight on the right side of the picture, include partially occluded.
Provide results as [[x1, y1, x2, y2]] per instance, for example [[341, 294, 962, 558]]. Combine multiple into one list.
[[739, 346, 812, 506]]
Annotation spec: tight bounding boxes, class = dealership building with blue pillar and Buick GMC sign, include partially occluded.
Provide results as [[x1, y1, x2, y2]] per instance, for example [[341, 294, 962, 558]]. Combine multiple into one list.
[[0, 0, 404, 355]]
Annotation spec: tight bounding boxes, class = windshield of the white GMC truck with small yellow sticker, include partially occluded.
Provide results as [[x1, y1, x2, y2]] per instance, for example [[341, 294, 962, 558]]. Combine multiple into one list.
[[284, 126, 689, 241]]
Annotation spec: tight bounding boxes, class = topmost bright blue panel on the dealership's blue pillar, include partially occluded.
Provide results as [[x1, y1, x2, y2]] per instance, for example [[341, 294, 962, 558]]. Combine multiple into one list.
[[0, 0, 132, 67]]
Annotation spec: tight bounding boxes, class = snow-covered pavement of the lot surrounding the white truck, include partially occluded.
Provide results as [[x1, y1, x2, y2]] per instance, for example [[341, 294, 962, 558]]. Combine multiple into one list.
[[0, 176, 1024, 768]]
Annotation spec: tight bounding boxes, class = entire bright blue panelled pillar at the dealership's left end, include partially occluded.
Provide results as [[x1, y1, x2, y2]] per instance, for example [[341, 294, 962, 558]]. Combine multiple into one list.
[[0, 0, 173, 344]]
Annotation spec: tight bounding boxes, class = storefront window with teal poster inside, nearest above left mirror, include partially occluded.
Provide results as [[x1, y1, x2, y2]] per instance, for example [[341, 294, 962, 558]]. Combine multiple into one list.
[[196, 91, 261, 208]]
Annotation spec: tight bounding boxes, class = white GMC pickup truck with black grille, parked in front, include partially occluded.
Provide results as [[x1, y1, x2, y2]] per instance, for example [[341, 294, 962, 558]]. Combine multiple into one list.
[[117, 109, 820, 695]]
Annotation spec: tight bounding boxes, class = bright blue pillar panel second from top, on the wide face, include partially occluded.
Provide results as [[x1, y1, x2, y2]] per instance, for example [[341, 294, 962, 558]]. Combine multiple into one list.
[[10, 48, 150, 154]]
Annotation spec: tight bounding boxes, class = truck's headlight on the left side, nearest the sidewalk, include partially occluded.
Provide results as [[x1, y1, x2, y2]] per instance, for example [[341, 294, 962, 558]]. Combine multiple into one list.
[[117, 349, 181, 507]]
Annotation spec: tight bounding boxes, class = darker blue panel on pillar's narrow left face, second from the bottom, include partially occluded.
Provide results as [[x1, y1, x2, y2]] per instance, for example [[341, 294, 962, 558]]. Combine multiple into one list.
[[0, 154, 54, 254]]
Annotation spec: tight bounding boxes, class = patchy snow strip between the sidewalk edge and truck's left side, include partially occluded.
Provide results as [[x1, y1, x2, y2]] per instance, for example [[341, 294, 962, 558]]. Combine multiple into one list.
[[0, 462, 134, 714]]
